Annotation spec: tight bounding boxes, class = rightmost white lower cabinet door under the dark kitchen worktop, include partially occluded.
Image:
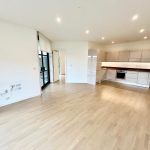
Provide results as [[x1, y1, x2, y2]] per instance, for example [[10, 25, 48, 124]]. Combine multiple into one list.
[[137, 72, 149, 85]]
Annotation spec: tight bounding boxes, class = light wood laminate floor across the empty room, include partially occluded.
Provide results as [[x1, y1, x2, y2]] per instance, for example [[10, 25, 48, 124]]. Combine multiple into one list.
[[0, 83, 150, 150]]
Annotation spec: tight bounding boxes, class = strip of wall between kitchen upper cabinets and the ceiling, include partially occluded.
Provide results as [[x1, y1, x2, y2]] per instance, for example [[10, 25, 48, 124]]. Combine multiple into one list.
[[103, 40, 150, 51]]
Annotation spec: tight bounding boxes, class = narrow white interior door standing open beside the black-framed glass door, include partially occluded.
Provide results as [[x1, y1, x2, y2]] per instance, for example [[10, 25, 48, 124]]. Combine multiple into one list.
[[53, 51, 59, 82]]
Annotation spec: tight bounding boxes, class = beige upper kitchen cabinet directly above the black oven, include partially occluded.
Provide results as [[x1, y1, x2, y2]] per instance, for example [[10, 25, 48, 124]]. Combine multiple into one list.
[[118, 51, 130, 62]]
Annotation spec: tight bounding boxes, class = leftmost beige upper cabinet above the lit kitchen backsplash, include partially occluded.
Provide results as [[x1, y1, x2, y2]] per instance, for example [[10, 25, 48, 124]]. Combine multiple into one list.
[[106, 52, 119, 62]]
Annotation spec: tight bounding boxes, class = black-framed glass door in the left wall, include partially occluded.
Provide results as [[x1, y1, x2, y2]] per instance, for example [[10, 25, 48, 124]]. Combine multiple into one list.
[[39, 51, 50, 89]]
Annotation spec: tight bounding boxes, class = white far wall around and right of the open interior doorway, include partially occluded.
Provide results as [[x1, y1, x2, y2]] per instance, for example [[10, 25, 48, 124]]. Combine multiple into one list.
[[52, 41, 88, 83]]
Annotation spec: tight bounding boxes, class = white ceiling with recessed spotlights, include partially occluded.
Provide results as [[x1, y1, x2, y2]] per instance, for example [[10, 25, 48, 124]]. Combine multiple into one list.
[[0, 0, 150, 44]]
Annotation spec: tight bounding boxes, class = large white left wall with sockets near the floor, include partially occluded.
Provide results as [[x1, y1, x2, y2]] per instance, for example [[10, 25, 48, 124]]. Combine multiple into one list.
[[0, 22, 41, 106]]
